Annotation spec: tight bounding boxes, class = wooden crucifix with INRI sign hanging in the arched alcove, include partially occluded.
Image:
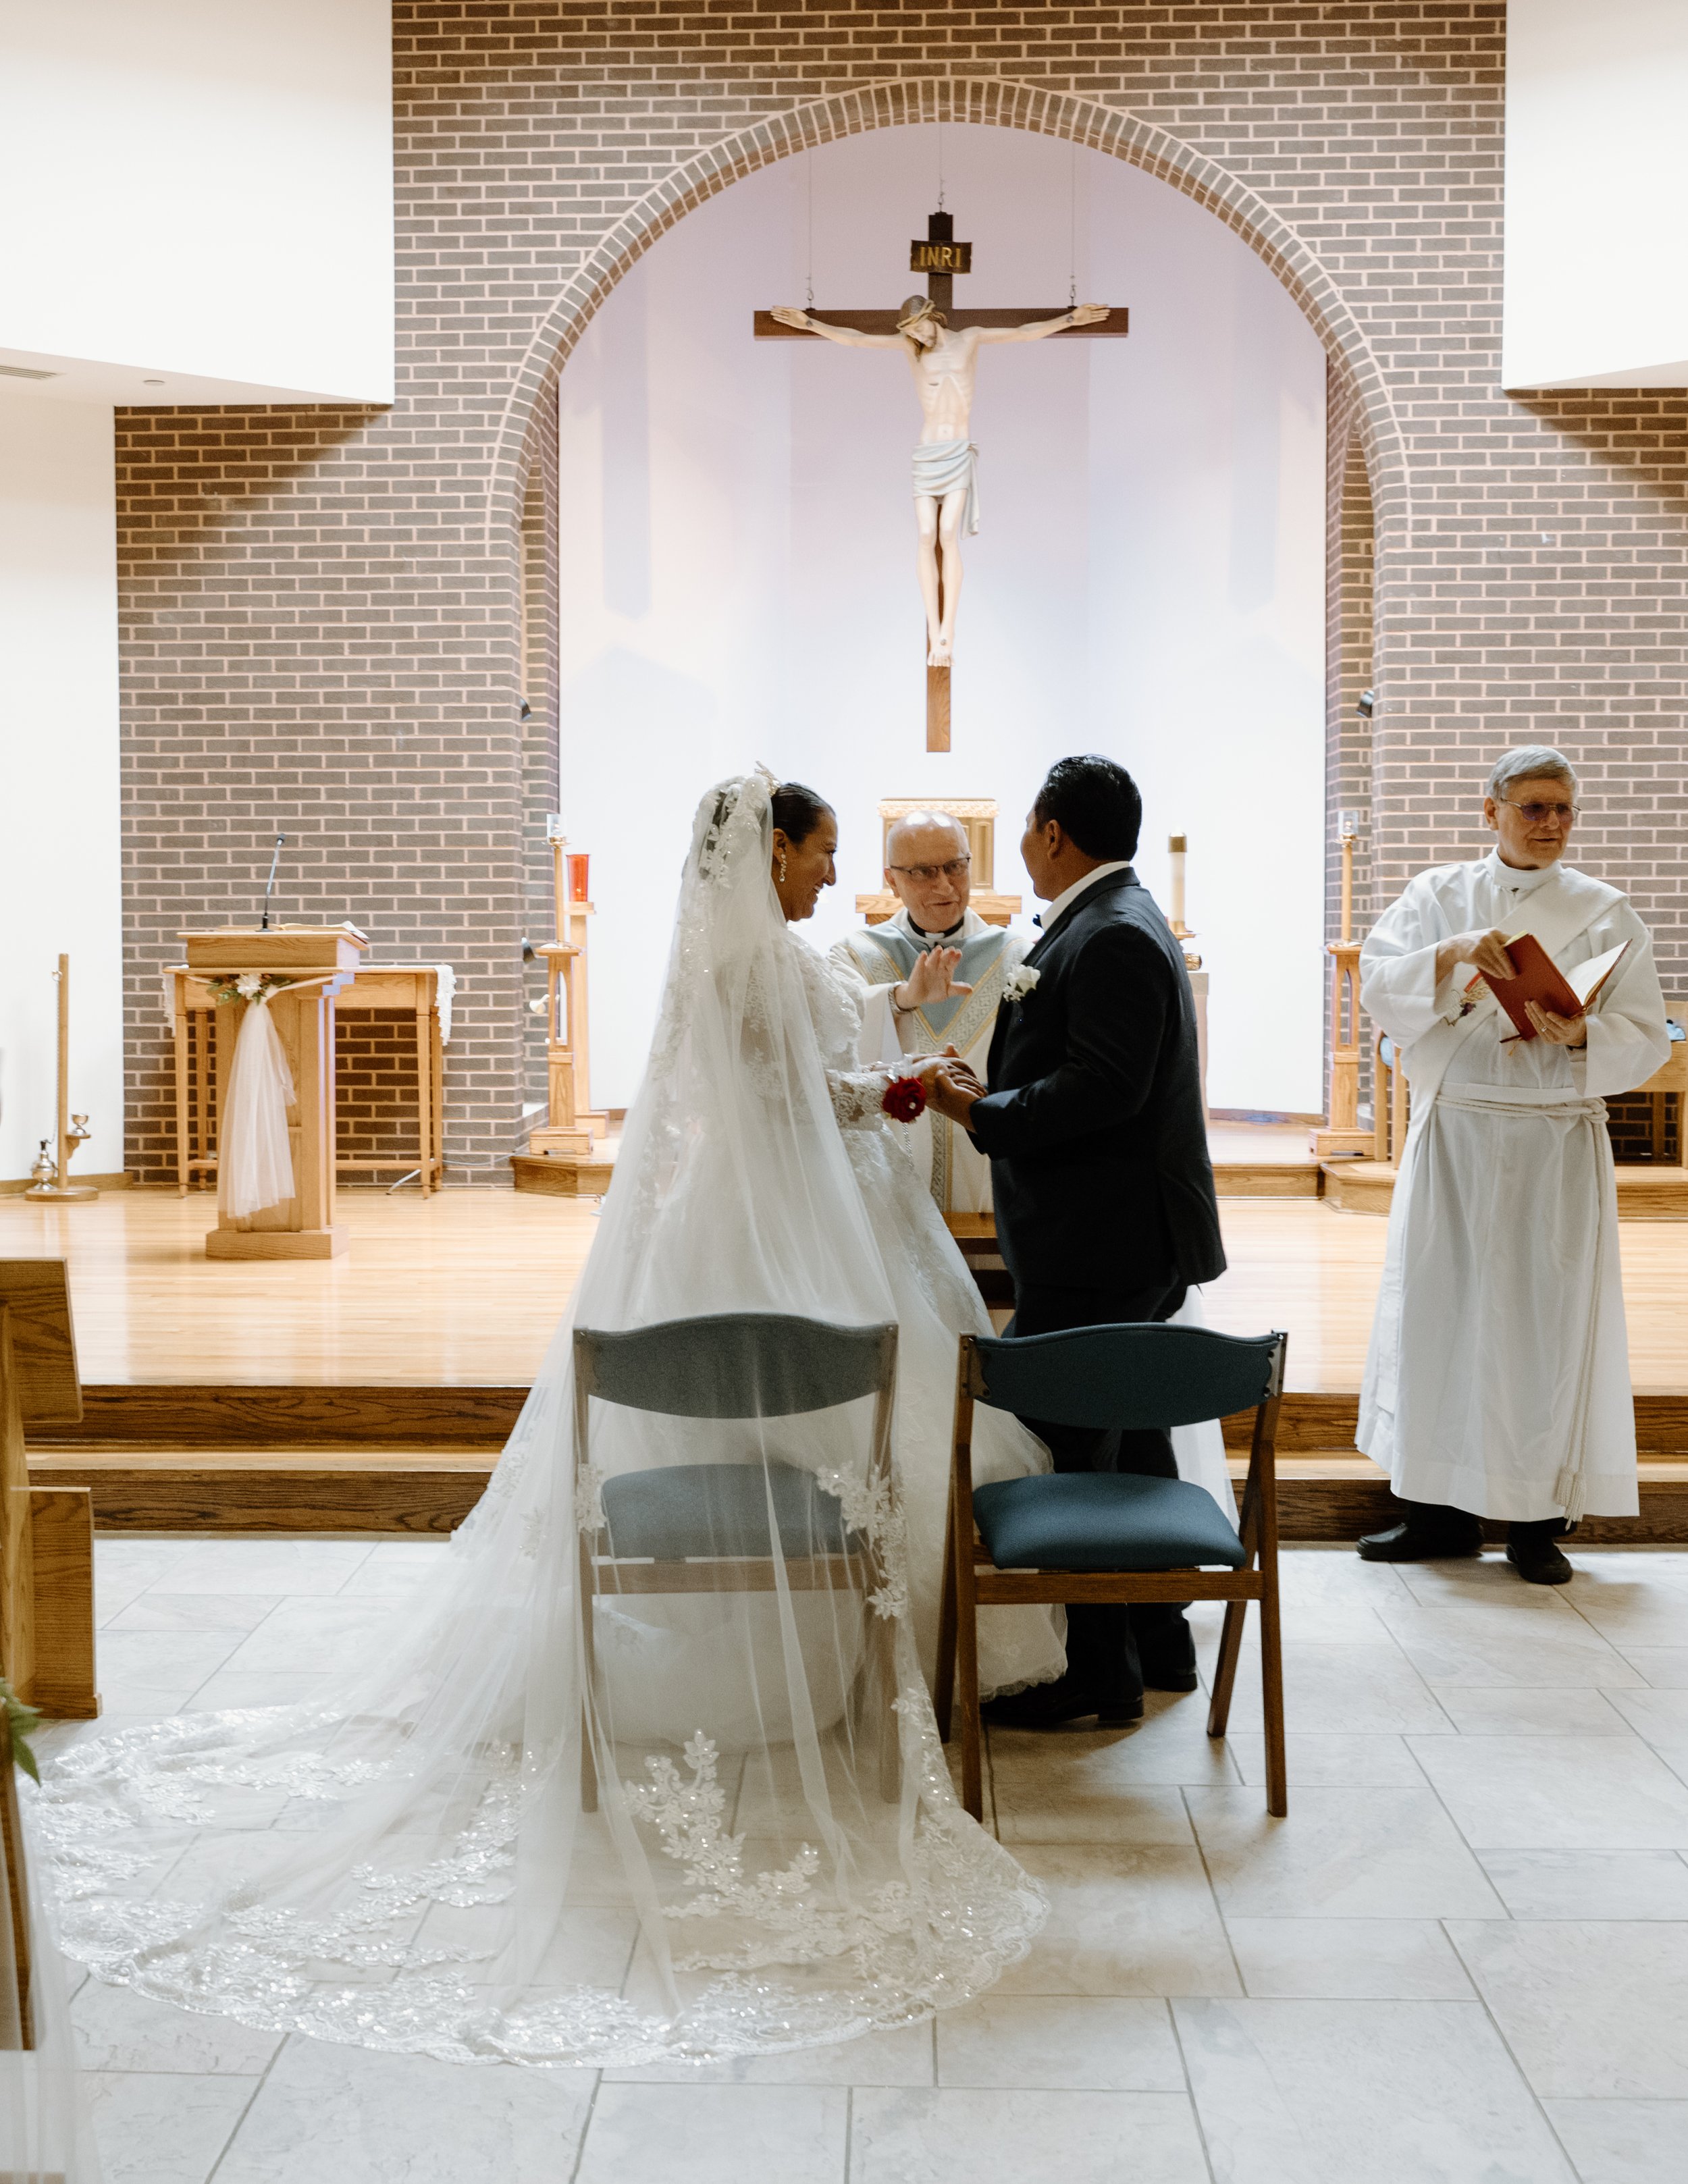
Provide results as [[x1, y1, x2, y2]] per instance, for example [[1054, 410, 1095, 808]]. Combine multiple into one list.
[[754, 212, 1129, 751]]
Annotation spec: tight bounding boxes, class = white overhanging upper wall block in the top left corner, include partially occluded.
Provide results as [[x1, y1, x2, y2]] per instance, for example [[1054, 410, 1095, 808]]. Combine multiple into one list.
[[0, 0, 393, 404]]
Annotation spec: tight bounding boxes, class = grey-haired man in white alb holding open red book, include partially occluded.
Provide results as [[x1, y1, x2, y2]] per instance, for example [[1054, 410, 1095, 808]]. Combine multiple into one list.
[[1359, 745, 1670, 1586]]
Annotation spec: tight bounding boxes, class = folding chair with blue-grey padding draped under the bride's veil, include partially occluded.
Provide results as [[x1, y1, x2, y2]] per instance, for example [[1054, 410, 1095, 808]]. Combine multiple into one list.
[[575, 1312, 899, 1813]]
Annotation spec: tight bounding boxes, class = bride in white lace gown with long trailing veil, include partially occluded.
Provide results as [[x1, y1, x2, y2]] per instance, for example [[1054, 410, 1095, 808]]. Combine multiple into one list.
[[33, 773, 1061, 2066]]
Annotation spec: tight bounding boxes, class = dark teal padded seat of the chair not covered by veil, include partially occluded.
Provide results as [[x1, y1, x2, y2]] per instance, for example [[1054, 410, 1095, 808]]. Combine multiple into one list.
[[974, 1472, 1244, 1570]]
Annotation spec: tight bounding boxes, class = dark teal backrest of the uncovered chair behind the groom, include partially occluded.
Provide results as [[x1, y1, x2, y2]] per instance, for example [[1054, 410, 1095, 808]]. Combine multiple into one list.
[[968, 1321, 1284, 1429]]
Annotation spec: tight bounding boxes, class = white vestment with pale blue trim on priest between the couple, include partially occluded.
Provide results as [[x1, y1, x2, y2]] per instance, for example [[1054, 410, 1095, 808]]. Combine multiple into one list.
[[830, 909, 1037, 1215]]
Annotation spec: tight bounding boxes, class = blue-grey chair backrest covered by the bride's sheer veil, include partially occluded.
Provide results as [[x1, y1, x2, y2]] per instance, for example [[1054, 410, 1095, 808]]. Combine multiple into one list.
[[575, 1312, 897, 1418]]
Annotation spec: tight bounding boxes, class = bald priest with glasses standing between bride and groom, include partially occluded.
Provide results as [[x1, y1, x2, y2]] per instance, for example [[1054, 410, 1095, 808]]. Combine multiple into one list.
[[832, 810, 1033, 1215]]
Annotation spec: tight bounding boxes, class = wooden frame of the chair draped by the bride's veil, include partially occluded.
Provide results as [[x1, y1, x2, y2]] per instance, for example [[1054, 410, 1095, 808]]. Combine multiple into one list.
[[575, 1323, 902, 1813]]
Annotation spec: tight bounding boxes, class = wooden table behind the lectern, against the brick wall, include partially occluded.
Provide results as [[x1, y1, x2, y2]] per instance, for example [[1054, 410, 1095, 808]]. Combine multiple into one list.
[[164, 963, 446, 1199]]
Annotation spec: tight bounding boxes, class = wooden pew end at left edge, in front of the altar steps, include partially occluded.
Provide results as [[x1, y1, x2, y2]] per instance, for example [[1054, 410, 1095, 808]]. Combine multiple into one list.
[[0, 1258, 101, 1721]]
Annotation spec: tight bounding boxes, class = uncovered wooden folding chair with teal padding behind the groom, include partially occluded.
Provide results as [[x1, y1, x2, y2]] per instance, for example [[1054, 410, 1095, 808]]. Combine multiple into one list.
[[937, 1321, 1288, 1819]]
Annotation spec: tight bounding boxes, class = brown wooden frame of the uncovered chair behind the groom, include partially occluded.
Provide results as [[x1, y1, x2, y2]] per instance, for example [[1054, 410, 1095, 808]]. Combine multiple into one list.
[[934, 1335, 1288, 1819]]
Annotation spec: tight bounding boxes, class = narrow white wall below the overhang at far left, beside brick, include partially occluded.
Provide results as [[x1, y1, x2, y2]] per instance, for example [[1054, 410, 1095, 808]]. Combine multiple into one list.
[[0, 398, 122, 1179]]
